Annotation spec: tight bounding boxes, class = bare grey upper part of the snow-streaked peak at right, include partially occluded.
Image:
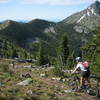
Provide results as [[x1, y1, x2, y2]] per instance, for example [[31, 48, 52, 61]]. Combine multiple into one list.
[[62, 1, 100, 29]]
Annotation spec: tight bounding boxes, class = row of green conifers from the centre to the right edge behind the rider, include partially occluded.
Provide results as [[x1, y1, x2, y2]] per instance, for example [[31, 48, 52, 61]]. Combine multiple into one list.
[[38, 28, 100, 74]]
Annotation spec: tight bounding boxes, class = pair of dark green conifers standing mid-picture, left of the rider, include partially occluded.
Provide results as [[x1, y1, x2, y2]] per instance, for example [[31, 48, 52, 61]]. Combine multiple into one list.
[[37, 34, 74, 68]]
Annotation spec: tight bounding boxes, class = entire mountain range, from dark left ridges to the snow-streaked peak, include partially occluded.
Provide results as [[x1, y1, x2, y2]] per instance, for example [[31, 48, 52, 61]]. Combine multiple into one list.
[[0, 1, 100, 56]]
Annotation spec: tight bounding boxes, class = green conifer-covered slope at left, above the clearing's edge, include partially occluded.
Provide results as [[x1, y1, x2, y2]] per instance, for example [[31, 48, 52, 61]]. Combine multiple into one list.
[[0, 38, 33, 59]]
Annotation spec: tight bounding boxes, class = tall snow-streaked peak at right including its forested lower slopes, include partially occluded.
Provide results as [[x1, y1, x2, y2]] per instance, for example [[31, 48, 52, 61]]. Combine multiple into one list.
[[55, 1, 100, 52]]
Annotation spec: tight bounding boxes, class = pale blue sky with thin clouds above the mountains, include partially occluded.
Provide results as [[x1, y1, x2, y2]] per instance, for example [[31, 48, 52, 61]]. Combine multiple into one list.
[[0, 0, 100, 21]]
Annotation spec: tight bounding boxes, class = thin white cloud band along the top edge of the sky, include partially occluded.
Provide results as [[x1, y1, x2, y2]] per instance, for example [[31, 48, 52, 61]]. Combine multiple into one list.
[[21, 0, 96, 5]]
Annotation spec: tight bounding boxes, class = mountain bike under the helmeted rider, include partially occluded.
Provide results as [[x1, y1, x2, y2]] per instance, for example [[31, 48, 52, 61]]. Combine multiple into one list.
[[67, 72, 100, 97]]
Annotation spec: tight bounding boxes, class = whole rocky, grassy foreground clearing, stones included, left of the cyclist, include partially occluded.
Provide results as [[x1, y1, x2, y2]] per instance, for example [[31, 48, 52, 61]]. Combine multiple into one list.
[[0, 60, 100, 100]]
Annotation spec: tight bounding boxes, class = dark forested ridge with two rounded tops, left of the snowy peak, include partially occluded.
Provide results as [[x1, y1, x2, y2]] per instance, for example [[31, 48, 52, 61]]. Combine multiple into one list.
[[0, 19, 54, 44]]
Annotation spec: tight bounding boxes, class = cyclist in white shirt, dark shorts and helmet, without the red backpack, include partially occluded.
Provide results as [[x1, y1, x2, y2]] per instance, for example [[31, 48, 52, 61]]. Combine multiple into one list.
[[72, 57, 91, 88]]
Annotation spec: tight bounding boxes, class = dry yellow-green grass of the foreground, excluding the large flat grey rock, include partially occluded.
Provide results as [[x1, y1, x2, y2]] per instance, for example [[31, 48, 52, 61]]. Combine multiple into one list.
[[0, 61, 99, 100]]
